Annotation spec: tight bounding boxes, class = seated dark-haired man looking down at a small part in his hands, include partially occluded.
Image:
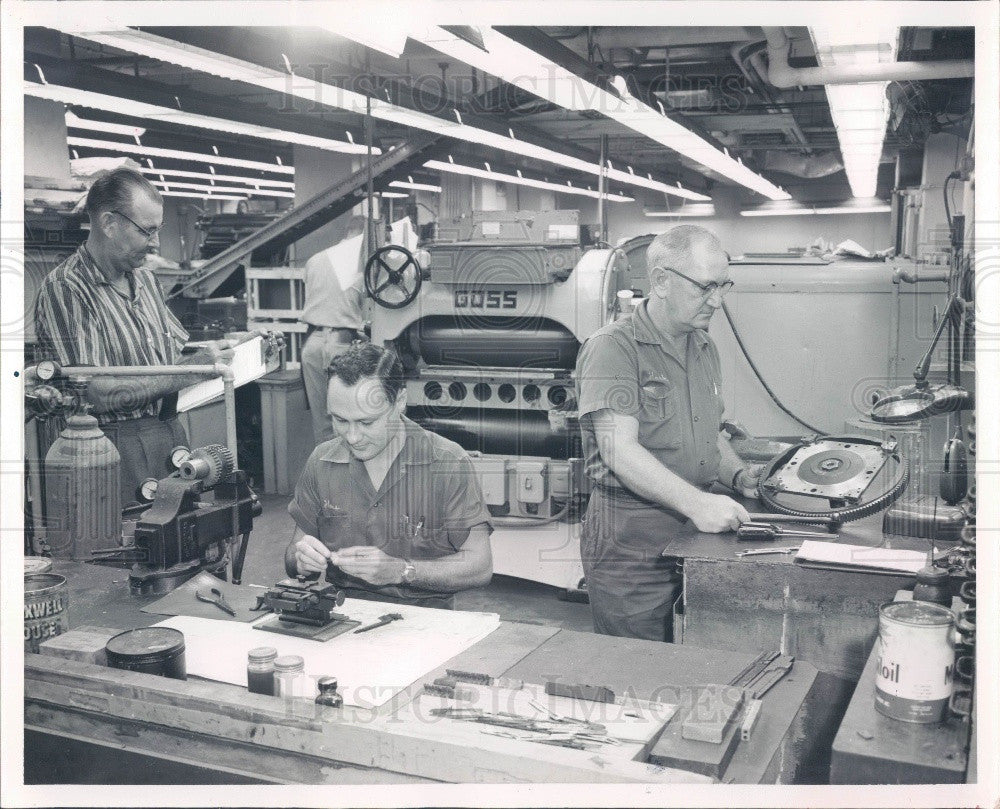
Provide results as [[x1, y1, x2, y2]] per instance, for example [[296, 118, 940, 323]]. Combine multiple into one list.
[[285, 344, 493, 609]]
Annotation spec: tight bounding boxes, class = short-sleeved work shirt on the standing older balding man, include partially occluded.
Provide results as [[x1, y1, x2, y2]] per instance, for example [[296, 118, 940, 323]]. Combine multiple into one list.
[[576, 301, 724, 488]]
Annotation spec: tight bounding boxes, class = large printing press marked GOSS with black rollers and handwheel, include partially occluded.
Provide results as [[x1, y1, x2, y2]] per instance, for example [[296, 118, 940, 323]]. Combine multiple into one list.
[[366, 210, 631, 526]]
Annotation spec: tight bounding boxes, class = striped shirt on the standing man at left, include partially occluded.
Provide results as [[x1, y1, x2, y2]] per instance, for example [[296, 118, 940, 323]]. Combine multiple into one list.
[[34, 244, 188, 424]]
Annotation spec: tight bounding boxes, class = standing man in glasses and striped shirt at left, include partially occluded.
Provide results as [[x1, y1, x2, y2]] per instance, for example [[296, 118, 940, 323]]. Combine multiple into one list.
[[34, 168, 232, 505]]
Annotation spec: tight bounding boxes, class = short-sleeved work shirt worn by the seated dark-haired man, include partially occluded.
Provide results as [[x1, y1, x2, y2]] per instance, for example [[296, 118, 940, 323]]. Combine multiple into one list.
[[288, 418, 492, 600]]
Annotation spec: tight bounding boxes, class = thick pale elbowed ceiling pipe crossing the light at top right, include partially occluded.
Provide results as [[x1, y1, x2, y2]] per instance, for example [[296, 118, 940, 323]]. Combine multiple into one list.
[[763, 27, 975, 88]]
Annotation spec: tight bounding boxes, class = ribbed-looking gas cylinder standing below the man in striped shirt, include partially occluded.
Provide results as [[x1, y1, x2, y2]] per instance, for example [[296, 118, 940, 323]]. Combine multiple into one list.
[[45, 415, 122, 559]]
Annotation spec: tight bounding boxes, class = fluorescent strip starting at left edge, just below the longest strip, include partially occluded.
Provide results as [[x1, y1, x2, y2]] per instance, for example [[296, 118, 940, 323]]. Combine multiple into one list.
[[24, 81, 365, 154]]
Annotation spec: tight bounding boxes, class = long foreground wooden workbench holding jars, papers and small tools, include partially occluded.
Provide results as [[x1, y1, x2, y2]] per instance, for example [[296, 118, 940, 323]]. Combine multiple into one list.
[[25, 561, 817, 784]]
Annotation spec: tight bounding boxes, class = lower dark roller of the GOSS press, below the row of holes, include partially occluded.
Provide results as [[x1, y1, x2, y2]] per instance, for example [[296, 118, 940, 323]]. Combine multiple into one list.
[[406, 407, 582, 460]]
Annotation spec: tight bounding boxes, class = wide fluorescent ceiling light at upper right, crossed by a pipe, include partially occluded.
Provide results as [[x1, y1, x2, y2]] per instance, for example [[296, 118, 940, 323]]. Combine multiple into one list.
[[809, 26, 899, 198]]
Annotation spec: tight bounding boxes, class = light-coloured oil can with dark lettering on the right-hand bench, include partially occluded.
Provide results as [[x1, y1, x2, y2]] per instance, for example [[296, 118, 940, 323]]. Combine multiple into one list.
[[875, 601, 955, 722]]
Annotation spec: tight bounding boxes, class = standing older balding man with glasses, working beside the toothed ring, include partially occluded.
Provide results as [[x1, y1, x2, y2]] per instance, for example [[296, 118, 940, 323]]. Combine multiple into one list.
[[577, 225, 756, 640]]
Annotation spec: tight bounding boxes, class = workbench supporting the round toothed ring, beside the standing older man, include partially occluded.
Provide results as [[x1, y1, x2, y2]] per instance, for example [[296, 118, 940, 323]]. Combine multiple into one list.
[[663, 508, 948, 783]]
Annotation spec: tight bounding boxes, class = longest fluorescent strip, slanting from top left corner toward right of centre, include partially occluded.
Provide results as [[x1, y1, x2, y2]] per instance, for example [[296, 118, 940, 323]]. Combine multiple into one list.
[[52, 27, 696, 202]]
